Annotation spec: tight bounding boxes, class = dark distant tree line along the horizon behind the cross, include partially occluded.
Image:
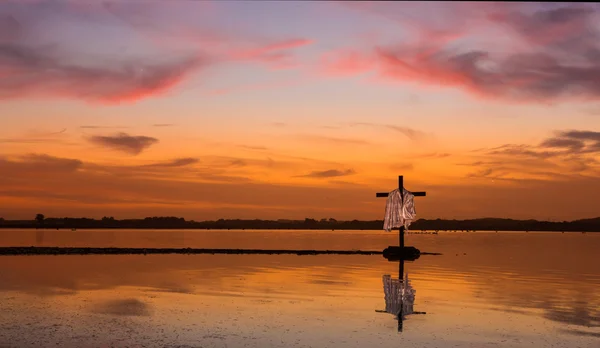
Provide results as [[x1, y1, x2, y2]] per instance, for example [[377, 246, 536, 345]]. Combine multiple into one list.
[[0, 214, 600, 232]]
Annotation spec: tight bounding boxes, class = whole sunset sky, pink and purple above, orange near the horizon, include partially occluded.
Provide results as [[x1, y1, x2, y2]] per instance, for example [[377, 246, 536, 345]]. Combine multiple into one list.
[[0, 0, 600, 221]]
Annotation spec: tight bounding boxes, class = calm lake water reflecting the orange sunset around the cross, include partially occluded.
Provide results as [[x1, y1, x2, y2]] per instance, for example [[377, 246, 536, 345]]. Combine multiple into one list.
[[0, 230, 600, 348]]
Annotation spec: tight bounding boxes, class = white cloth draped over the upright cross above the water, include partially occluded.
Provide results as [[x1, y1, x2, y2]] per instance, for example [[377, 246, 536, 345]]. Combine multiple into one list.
[[383, 187, 417, 232]]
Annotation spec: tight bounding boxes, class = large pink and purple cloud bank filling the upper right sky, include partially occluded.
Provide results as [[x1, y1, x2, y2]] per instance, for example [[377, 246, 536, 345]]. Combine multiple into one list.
[[326, 5, 600, 103]]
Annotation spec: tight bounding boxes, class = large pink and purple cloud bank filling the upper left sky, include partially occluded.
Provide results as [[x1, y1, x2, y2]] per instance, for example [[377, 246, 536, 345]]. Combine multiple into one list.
[[0, 2, 312, 104]]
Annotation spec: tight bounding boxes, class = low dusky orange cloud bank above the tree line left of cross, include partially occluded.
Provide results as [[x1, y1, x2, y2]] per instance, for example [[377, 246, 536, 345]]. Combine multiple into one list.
[[0, 153, 380, 219]]
